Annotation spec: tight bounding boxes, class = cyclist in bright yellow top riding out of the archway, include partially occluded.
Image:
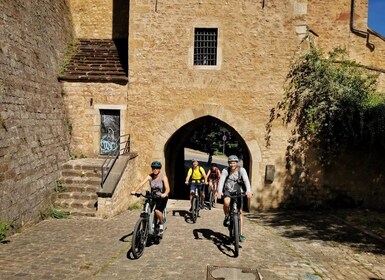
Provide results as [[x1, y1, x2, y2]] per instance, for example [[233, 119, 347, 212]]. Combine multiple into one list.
[[185, 159, 207, 212]]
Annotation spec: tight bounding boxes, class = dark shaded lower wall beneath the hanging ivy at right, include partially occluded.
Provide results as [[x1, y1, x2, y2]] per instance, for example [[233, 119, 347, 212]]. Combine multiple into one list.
[[261, 147, 385, 210]]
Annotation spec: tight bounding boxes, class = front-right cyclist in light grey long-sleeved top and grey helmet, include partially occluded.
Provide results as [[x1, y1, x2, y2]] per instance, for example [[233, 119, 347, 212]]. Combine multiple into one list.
[[217, 155, 252, 242]]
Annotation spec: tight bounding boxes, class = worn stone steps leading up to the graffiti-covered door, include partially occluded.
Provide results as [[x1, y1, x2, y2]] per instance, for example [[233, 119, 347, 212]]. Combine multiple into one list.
[[53, 159, 104, 217]]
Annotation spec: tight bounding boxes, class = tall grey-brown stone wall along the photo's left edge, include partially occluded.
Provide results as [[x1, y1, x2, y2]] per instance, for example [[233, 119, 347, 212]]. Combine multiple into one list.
[[0, 0, 72, 227]]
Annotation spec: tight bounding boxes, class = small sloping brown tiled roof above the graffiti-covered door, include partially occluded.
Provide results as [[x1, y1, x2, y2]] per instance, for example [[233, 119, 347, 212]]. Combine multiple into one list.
[[59, 39, 128, 84]]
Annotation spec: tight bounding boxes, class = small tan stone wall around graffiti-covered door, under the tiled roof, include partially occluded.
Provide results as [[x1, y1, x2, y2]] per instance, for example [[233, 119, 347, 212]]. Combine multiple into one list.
[[62, 82, 128, 157]]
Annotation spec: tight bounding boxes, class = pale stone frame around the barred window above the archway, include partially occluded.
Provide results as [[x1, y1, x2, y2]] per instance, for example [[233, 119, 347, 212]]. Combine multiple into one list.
[[188, 23, 223, 70]]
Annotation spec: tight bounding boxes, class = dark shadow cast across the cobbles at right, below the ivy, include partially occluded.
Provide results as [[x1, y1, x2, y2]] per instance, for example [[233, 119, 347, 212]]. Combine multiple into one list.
[[246, 210, 385, 255]]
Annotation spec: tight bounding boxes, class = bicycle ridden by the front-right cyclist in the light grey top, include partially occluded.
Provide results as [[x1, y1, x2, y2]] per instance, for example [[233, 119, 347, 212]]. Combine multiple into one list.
[[228, 192, 246, 257]]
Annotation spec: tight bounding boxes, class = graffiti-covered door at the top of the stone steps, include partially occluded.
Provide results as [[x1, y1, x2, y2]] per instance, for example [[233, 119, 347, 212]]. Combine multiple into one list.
[[100, 110, 120, 155]]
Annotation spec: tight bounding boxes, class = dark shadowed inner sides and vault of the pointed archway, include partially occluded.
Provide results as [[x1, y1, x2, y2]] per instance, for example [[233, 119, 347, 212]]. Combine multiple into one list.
[[164, 116, 252, 199]]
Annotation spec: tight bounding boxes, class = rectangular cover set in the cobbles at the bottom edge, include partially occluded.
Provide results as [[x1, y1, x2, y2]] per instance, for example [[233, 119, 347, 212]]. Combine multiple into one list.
[[206, 265, 262, 280]]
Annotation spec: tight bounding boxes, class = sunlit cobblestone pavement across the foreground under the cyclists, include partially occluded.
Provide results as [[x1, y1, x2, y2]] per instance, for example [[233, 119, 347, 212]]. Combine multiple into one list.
[[0, 200, 385, 280]]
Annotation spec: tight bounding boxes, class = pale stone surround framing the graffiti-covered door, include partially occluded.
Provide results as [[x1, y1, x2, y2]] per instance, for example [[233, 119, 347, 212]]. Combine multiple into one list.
[[92, 104, 127, 155]]
